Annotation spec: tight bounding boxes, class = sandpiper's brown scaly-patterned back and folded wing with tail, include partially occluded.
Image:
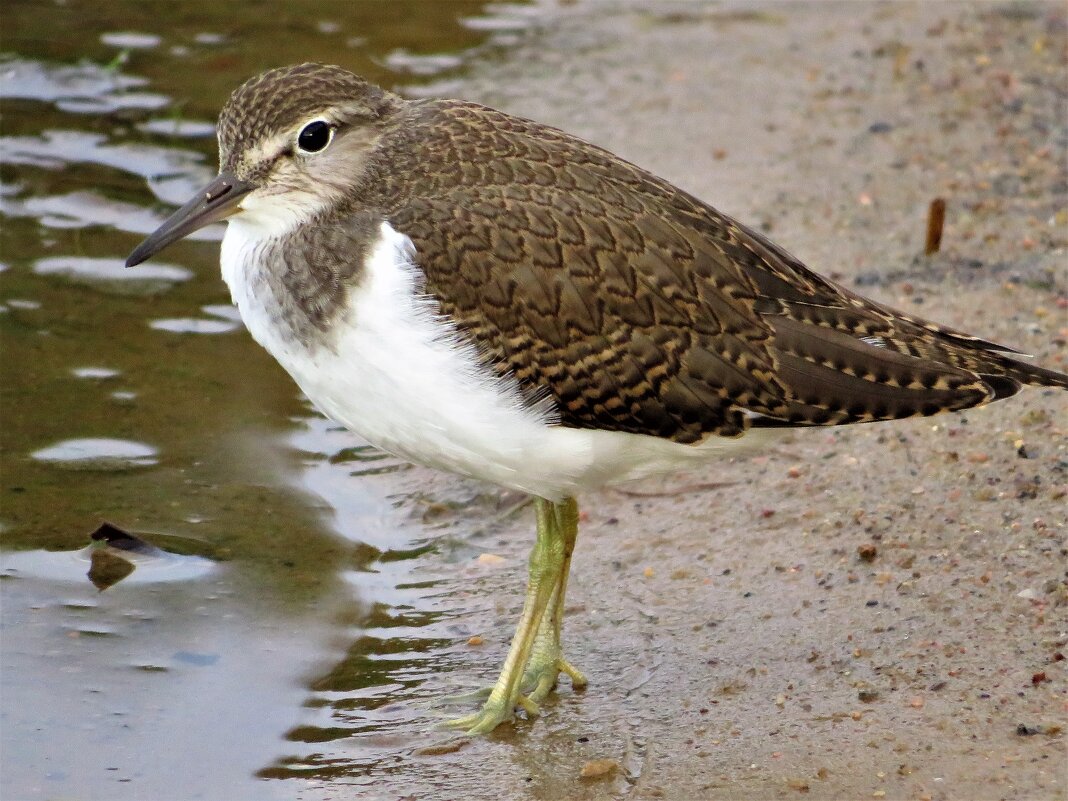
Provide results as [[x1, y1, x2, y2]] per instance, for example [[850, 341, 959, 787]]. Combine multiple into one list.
[[360, 101, 1068, 442]]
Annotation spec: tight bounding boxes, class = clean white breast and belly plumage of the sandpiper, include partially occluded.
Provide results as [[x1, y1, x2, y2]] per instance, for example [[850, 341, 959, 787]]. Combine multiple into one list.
[[222, 217, 764, 500]]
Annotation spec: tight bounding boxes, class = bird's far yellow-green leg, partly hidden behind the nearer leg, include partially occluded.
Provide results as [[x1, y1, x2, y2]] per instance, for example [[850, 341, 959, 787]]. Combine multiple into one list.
[[522, 498, 586, 704]]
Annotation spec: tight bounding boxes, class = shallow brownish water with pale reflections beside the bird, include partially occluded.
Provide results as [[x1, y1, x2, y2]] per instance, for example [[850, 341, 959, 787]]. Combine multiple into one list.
[[0, 0, 536, 801]]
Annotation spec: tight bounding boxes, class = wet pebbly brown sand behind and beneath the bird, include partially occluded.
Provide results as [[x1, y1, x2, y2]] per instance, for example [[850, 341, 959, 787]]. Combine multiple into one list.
[[302, 2, 1068, 801]]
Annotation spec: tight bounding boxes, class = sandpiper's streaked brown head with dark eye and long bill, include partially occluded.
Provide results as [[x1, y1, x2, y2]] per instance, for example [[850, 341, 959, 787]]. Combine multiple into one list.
[[126, 64, 404, 267]]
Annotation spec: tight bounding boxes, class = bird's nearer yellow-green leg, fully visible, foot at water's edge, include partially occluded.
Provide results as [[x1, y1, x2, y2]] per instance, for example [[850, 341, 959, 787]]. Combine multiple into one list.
[[445, 498, 574, 734]]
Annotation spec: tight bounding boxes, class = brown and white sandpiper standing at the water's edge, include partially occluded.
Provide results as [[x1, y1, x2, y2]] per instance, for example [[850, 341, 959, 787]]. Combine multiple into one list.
[[126, 63, 1068, 735]]
